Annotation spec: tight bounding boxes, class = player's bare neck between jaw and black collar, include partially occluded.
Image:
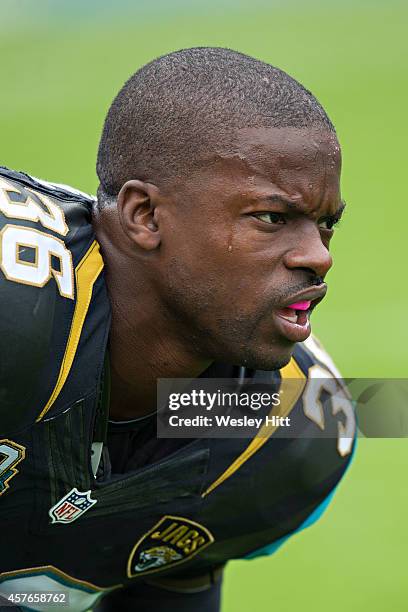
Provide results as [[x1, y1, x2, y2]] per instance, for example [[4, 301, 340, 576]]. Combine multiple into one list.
[[96, 208, 211, 420]]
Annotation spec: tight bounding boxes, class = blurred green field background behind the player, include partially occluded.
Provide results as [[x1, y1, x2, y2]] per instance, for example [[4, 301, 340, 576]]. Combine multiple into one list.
[[0, 0, 408, 612]]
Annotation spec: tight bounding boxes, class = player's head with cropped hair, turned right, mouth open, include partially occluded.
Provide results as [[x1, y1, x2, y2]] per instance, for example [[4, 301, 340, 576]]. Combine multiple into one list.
[[97, 48, 341, 369]]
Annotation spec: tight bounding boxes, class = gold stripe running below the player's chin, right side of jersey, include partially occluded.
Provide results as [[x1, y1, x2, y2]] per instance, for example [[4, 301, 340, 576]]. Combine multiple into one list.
[[202, 357, 306, 497]]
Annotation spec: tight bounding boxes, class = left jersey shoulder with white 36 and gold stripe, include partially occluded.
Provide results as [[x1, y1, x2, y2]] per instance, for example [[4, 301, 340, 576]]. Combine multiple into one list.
[[0, 167, 110, 434]]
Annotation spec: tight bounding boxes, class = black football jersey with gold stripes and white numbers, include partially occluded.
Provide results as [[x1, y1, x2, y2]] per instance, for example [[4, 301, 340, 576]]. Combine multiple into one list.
[[0, 169, 354, 612]]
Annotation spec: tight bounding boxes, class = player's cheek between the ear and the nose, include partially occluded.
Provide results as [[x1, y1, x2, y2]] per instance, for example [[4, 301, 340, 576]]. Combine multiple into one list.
[[161, 216, 287, 314]]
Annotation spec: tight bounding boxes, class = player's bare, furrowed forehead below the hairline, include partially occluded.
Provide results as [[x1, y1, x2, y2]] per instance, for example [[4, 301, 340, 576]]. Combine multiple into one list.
[[196, 128, 341, 215]]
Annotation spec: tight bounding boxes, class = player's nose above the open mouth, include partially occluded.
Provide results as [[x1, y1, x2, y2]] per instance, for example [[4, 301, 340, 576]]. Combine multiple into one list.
[[284, 223, 333, 278]]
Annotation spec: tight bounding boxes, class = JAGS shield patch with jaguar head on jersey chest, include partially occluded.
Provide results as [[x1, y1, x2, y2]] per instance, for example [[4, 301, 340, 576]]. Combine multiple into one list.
[[127, 515, 214, 578]]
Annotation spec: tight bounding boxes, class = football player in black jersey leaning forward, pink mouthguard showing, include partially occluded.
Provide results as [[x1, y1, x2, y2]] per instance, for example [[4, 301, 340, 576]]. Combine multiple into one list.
[[0, 48, 354, 612]]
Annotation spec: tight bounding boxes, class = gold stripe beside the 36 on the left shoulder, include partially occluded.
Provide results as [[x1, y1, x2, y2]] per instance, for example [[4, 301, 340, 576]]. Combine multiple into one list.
[[36, 240, 103, 423]]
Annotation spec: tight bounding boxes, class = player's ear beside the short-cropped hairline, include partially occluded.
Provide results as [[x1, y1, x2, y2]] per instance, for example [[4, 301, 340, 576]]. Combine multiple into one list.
[[117, 180, 161, 251]]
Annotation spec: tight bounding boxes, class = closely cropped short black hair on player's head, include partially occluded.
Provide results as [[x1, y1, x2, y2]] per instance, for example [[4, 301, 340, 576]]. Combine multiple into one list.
[[97, 47, 334, 204]]
